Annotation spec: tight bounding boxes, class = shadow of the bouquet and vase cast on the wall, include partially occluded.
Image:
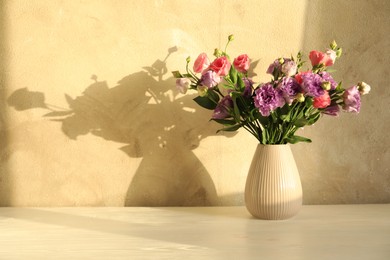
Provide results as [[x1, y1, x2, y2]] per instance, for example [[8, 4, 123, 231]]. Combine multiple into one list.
[[8, 47, 236, 206]]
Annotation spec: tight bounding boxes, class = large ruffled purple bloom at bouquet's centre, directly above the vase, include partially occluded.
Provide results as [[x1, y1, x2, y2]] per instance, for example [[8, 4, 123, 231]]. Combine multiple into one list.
[[254, 83, 285, 116]]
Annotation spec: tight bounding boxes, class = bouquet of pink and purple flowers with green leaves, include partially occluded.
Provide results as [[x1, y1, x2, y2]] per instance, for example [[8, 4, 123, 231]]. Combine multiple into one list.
[[172, 35, 370, 144]]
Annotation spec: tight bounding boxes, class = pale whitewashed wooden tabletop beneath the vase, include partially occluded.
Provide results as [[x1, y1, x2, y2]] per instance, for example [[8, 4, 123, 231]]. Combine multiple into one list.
[[0, 204, 390, 260]]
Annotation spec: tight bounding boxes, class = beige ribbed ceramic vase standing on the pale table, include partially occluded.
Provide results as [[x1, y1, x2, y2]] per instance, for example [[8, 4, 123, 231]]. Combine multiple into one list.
[[245, 144, 302, 220]]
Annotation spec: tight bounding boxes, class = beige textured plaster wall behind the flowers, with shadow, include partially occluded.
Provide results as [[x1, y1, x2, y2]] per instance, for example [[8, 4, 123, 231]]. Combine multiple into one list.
[[0, 0, 390, 206]]
